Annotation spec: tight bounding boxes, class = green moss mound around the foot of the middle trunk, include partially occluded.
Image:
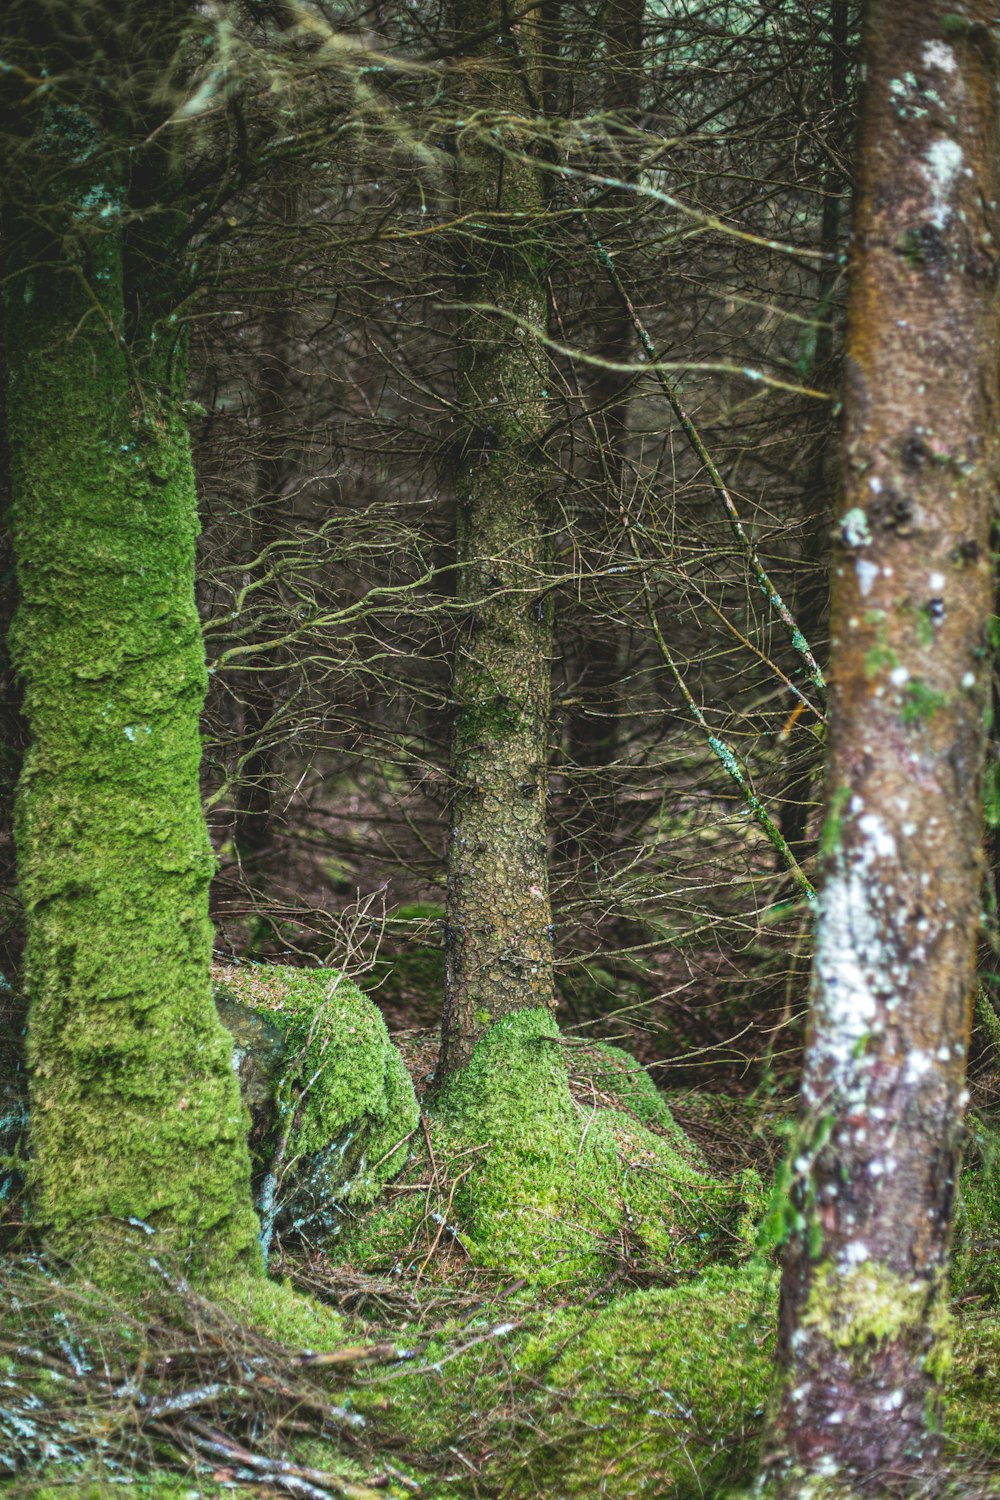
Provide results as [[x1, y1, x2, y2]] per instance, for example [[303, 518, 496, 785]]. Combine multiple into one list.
[[337, 1010, 760, 1286]]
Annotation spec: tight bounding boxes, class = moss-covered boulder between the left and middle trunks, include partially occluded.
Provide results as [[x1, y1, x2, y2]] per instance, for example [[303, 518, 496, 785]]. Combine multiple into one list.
[[213, 963, 418, 1235]]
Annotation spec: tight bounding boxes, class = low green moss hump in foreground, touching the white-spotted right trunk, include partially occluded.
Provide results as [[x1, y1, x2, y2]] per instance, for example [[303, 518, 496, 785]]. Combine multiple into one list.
[[375, 1268, 777, 1500]]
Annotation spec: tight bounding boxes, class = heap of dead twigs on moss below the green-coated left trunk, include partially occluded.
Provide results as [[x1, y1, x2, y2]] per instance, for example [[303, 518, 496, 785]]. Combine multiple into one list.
[[0, 1257, 379, 1500]]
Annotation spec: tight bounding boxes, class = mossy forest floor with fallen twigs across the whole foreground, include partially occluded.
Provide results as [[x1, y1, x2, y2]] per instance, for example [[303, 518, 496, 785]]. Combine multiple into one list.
[[7, 1260, 1000, 1500]]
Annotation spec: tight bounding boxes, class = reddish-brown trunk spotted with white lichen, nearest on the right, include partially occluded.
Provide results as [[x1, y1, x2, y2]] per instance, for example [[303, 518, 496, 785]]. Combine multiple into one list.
[[769, 0, 1000, 1497]]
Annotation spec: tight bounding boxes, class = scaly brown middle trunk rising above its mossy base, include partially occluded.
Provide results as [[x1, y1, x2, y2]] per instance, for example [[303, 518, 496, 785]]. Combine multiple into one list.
[[438, 0, 553, 1079]]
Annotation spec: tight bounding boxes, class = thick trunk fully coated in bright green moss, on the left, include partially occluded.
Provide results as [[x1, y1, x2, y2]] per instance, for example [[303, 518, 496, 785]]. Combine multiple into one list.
[[6, 132, 256, 1275]]
